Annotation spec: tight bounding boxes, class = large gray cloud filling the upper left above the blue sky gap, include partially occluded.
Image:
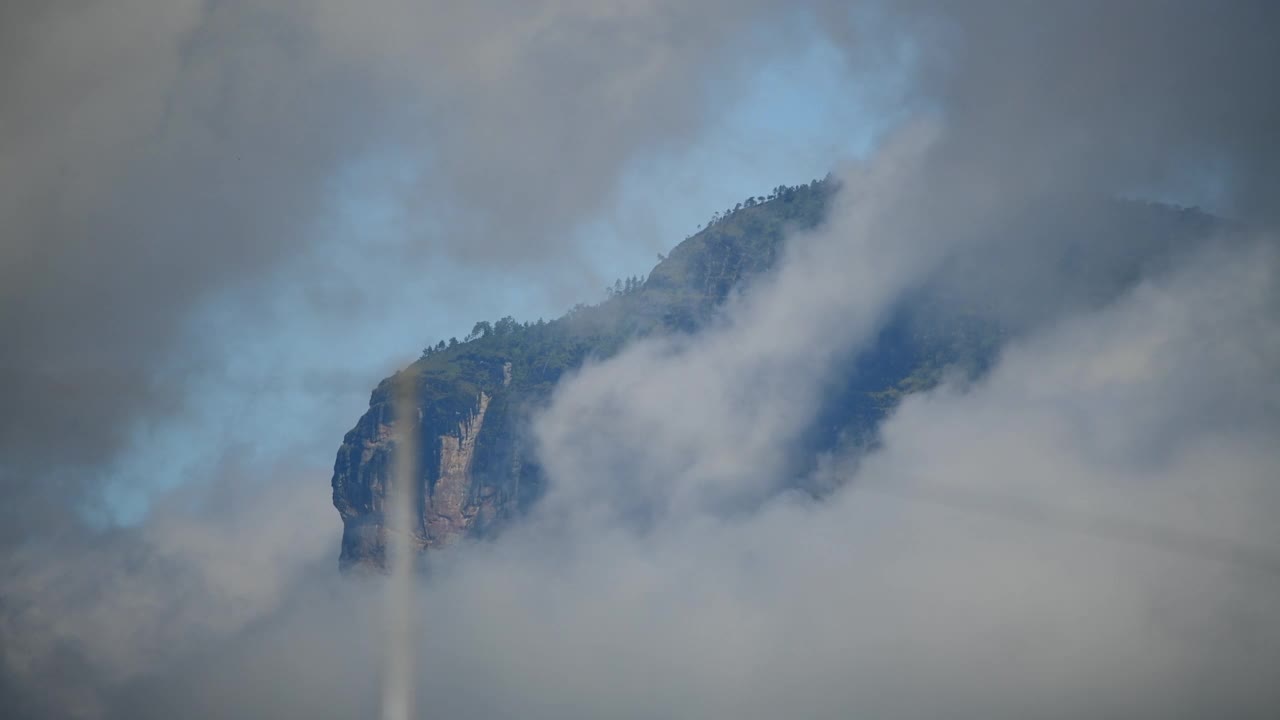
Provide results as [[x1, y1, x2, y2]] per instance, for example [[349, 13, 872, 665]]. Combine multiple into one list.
[[0, 0, 814, 539]]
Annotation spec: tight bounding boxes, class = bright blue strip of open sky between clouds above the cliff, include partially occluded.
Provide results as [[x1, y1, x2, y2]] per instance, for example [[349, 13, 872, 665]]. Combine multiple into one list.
[[84, 19, 878, 524]]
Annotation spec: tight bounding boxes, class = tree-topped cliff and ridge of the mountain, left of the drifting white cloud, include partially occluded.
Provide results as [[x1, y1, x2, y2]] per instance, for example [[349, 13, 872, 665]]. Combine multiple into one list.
[[333, 182, 832, 569]]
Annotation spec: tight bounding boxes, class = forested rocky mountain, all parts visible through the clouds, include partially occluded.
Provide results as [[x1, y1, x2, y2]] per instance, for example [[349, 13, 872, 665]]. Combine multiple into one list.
[[333, 178, 1207, 570]]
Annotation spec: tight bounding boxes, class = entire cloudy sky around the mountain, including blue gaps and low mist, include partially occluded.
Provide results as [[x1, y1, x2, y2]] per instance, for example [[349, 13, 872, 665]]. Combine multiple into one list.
[[0, 0, 1280, 717]]
